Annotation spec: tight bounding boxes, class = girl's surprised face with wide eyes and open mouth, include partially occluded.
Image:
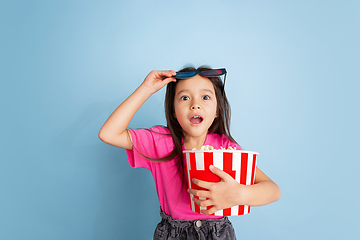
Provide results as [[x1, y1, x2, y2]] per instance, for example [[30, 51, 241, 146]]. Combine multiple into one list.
[[174, 75, 217, 140]]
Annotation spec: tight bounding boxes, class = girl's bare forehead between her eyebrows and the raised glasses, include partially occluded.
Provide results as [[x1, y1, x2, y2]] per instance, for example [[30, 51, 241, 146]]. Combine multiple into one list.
[[175, 75, 215, 94]]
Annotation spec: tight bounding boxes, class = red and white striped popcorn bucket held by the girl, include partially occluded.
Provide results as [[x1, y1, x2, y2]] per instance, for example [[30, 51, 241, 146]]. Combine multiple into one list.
[[183, 150, 259, 216]]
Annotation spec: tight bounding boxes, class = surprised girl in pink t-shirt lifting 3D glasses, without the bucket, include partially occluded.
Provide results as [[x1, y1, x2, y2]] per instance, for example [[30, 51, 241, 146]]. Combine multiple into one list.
[[99, 67, 280, 239]]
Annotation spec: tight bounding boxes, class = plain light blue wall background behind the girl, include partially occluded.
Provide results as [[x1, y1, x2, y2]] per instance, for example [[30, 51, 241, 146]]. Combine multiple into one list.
[[0, 0, 360, 240]]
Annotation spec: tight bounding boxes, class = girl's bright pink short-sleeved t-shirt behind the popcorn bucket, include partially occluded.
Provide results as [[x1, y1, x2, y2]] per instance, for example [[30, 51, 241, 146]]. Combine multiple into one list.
[[127, 126, 241, 220]]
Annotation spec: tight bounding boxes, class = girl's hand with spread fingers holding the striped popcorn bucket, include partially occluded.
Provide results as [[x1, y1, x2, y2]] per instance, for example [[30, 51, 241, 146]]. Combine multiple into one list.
[[188, 166, 248, 214]]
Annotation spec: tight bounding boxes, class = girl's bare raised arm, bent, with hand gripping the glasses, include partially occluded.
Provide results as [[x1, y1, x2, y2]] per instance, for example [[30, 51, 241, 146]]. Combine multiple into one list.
[[99, 70, 176, 149]]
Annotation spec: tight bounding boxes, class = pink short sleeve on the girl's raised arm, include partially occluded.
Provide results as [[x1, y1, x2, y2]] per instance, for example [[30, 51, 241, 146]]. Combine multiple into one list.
[[126, 126, 173, 169]]
